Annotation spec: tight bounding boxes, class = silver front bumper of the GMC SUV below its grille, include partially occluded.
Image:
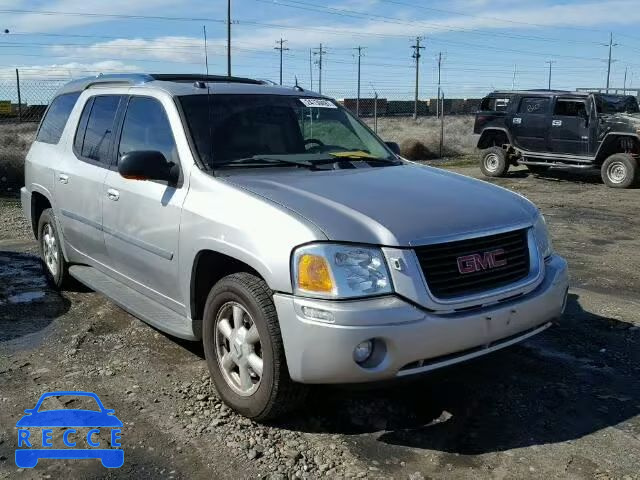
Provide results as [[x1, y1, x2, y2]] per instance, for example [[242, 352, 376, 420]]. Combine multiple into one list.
[[274, 256, 569, 383]]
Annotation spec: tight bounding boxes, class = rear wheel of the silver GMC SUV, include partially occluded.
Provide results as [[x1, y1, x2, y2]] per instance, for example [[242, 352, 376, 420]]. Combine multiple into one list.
[[38, 208, 69, 289]]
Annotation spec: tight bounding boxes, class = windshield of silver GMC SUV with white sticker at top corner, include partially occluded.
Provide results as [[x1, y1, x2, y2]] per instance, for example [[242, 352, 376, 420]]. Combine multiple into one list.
[[180, 94, 396, 168]]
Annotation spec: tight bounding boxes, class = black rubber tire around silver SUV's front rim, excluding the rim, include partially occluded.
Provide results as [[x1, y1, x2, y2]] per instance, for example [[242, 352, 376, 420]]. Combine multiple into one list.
[[202, 273, 307, 421]]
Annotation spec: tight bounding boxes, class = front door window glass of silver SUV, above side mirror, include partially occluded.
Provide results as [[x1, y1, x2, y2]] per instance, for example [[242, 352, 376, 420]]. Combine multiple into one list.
[[118, 97, 178, 163]]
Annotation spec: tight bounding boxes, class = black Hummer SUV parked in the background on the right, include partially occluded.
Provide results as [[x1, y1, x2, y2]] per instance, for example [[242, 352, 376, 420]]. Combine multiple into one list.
[[474, 90, 640, 188]]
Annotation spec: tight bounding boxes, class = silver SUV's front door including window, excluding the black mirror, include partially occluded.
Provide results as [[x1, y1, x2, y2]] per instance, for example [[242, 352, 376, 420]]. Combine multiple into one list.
[[103, 96, 186, 313]]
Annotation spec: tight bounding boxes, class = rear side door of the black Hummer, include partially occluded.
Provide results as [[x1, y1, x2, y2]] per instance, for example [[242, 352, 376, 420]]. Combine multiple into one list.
[[510, 96, 551, 152]]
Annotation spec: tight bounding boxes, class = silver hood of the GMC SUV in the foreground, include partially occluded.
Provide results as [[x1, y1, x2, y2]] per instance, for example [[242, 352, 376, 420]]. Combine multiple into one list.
[[225, 163, 537, 246]]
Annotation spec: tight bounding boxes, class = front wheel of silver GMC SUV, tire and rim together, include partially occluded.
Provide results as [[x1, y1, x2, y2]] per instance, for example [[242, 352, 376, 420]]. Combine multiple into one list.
[[202, 273, 306, 421]]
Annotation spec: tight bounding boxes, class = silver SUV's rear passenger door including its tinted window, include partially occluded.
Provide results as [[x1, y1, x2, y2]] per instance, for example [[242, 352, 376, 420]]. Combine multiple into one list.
[[55, 95, 122, 263]]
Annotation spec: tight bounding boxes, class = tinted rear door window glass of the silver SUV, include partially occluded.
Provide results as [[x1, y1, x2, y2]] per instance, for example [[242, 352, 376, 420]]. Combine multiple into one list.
[[80, 95, 120, 164]]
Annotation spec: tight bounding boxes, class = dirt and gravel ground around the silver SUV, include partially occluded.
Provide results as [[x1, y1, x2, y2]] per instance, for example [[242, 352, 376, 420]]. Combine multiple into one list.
[[0, 166, 640, 480]]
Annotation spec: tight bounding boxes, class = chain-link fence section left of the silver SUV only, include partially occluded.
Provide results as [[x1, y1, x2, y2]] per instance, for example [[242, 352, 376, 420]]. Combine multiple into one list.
[[0, 75, 65, 192]]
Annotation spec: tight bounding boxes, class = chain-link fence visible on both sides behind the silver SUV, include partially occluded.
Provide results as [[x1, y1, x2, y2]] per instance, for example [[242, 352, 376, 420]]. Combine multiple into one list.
[[0, 75, 480, 192]]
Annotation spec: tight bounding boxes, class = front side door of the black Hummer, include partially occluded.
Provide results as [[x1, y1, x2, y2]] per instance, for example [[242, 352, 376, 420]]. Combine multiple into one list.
[[549, 97, 589, 155]]
